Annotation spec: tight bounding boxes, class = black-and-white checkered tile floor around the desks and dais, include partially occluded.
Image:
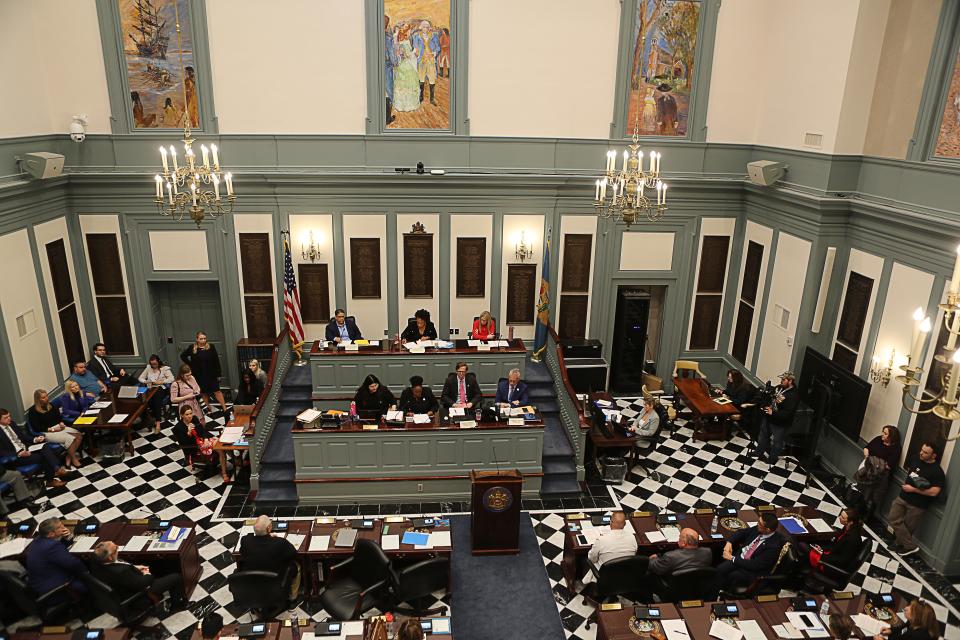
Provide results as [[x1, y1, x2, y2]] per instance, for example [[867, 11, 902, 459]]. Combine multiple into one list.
[[10, 401, 960, 640]]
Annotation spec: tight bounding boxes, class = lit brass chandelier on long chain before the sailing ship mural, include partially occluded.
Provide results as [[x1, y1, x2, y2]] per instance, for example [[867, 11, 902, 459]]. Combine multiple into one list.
[[153, 2, 237, 228]]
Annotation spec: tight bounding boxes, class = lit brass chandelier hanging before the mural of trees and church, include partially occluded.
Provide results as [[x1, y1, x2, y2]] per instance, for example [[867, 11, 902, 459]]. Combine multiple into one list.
[[593, 83, 667, 229]]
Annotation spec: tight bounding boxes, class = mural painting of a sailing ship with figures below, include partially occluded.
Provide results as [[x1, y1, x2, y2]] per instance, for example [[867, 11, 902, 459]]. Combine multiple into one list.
[[116, 0, 200, 129]]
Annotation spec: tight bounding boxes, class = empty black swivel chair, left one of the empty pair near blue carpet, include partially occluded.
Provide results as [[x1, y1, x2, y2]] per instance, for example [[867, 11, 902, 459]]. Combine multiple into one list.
[[320, 538, 397, 620]]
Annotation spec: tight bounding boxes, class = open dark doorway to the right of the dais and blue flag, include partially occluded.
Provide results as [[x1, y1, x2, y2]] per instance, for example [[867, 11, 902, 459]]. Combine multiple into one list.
[[610, 286, 666, 395]]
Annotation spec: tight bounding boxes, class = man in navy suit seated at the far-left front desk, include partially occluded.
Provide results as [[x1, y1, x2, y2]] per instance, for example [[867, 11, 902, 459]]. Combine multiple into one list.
[[26, 518, 87, 602]]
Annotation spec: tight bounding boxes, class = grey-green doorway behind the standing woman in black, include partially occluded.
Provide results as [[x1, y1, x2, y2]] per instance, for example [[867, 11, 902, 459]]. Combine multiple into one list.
[[149, 281, 230, 379]]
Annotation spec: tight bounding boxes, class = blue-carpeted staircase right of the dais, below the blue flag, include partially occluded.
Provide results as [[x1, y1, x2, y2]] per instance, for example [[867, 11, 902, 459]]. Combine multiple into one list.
[[524, 358, 580, 498]]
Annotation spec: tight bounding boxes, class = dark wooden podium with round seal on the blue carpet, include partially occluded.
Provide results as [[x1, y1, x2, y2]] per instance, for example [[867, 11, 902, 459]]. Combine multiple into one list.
[[470, 470, 523, 555]]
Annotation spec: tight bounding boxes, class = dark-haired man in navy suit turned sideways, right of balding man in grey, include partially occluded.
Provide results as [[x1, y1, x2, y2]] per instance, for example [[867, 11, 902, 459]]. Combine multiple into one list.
[[717, 511, 786, 589]]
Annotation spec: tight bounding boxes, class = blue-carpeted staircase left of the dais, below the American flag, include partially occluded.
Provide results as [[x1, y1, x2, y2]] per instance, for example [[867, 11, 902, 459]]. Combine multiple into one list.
[[256, 366, 313, 504]]
